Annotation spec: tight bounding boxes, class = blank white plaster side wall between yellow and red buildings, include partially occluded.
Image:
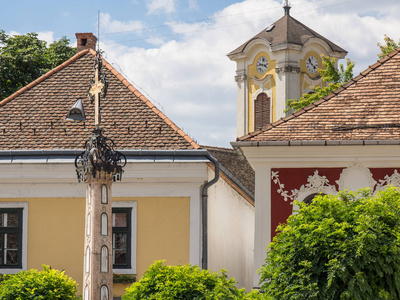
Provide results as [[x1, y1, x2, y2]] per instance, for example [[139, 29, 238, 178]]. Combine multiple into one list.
[[208, 170, 255, 290]]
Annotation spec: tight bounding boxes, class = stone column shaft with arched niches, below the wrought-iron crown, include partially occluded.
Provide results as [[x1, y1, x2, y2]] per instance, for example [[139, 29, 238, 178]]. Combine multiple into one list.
[[83, 171, 113, 300]]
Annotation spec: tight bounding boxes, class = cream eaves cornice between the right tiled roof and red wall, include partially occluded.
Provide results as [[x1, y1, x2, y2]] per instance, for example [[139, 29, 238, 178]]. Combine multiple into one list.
[[232, 140, 400, 169]]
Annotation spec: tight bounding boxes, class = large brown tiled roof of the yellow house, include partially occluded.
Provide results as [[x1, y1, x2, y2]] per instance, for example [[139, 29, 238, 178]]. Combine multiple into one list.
[[0, 50, 200, 150]]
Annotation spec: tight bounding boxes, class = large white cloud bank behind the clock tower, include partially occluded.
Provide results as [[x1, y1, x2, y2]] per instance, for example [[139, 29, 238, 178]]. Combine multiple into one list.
[[103, 0, 400, 146]]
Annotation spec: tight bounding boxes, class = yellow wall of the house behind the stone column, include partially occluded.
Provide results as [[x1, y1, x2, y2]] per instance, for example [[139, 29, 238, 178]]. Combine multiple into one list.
[[0, 197, 190, 296]]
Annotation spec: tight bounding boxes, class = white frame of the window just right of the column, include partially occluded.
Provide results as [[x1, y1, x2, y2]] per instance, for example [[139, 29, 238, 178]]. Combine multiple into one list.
[[112, 201, 137, 274]]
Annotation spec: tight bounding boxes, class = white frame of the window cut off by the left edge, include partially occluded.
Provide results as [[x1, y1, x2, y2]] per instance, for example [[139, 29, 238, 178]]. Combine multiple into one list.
[[0, 202, 28, 274]]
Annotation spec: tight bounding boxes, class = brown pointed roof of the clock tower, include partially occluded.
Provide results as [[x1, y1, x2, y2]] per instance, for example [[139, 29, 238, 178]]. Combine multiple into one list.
[[228, 12, 347, 56]]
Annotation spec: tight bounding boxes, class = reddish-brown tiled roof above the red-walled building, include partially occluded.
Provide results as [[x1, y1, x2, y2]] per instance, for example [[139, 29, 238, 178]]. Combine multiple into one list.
[[237, 48, 400, 141]]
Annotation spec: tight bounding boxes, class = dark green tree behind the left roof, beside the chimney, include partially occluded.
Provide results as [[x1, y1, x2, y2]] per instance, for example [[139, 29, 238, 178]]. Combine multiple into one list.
[[0, 30, 76, 100]]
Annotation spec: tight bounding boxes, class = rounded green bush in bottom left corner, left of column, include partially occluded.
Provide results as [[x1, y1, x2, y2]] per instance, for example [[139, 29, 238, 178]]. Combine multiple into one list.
[[0, 266, 79, 300]]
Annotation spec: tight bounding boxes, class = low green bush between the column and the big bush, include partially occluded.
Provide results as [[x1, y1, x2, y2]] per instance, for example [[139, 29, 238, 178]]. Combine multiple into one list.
[[122, 261, 262, 300]]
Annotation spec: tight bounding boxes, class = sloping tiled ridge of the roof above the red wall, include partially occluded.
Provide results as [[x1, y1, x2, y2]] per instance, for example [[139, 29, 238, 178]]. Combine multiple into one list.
[[236, 47, 400, 141]]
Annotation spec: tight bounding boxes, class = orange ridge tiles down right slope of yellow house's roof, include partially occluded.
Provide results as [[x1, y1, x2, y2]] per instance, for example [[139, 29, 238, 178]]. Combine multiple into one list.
[[101, 56, 201, 149]]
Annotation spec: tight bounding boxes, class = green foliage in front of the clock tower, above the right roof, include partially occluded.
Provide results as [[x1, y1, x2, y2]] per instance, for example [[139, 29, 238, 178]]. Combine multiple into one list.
[[285, 56, 355, 111]]
